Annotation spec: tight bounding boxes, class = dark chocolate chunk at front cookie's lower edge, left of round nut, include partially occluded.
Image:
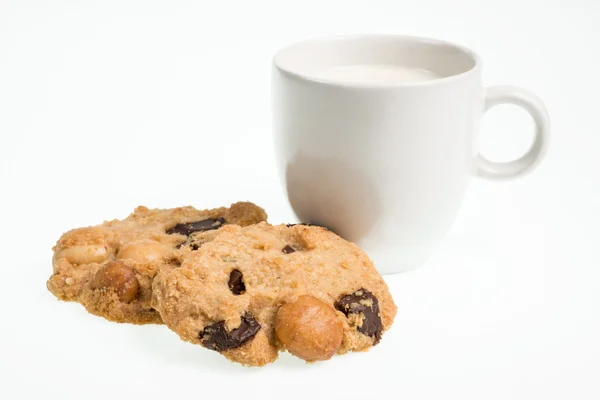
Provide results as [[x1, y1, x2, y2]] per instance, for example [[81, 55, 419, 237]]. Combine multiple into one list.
[[200, 313, 260, 351]]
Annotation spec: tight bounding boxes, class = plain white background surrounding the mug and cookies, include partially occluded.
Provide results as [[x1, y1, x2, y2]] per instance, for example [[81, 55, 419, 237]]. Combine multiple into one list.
[[0, 0, 600, 400]]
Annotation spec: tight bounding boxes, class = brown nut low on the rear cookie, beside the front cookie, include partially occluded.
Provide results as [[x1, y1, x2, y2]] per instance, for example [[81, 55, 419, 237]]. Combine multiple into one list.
[[92, 261, 139, 303]]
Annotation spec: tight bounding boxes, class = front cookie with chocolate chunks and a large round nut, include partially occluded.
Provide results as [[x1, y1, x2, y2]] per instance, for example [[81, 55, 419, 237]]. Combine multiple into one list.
[[152, 223, 396, 366]]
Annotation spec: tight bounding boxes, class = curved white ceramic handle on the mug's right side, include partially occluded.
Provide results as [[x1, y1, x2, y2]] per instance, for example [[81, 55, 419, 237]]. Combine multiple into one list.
[[477, 86, 550, 180]]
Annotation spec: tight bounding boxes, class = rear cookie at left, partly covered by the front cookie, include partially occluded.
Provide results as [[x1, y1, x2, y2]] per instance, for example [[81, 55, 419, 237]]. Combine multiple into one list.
[[47, 202, 267, 324]]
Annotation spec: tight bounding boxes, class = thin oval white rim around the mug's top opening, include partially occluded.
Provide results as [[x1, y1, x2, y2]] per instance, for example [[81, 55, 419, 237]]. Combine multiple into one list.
[[272, 33, 482, 89]]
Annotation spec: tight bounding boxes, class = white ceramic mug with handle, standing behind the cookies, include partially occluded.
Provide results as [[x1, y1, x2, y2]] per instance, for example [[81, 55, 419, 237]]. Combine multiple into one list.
[[273, 35, 550, 273]]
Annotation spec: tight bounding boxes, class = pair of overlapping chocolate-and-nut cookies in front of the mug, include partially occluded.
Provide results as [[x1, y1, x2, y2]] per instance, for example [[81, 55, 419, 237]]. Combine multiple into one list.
[[47, 202, 396, 366]]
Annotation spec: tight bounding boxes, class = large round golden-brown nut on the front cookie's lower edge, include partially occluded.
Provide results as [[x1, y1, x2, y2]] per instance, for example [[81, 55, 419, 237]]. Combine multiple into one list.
[[275, 296, 343, 361]]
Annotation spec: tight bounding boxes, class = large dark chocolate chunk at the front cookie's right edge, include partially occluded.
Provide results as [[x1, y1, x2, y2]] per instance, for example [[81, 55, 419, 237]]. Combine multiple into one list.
[[335, 289, 383, 345]]
